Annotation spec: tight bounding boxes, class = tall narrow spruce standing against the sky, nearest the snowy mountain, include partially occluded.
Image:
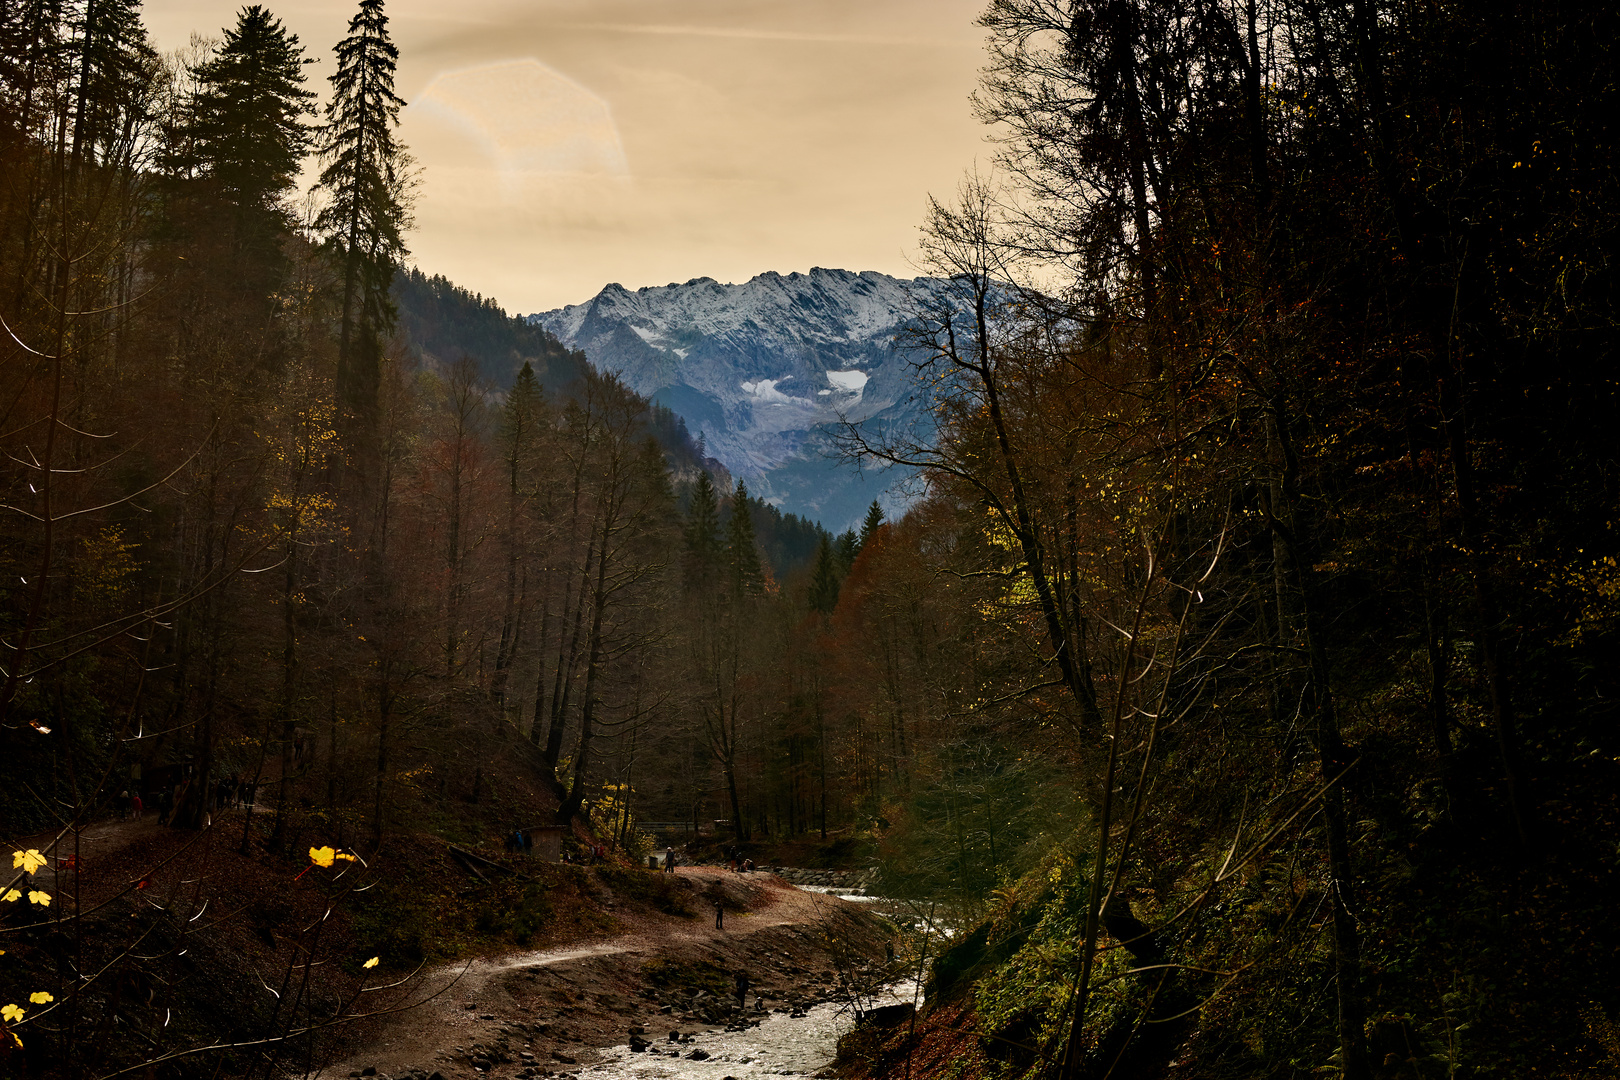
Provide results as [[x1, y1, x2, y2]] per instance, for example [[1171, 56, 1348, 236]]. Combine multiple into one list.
[[314, 0, 410, 426]]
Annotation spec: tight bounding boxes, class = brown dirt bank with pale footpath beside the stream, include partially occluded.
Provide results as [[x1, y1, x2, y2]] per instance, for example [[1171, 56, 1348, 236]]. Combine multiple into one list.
[[321, 866, 889, 1080]]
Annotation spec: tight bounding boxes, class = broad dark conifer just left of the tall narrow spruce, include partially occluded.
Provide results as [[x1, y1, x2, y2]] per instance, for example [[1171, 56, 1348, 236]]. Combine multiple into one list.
[[185, 5, 314, 275]]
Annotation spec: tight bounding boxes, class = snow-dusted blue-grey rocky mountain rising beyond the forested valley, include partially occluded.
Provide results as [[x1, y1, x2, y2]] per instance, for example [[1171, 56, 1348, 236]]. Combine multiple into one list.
[[530, 269, 936, 531]]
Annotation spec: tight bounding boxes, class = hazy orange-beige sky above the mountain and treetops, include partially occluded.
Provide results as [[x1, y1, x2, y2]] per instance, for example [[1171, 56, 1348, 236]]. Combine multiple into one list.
[[146, 0, 990, 313]]
